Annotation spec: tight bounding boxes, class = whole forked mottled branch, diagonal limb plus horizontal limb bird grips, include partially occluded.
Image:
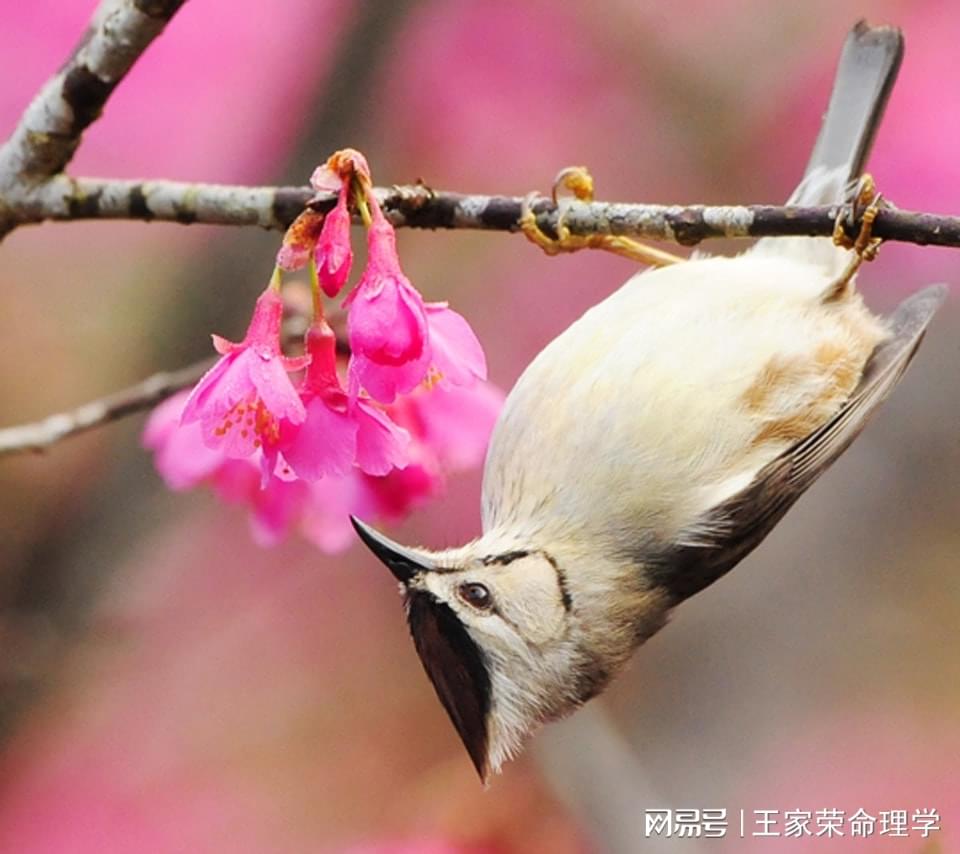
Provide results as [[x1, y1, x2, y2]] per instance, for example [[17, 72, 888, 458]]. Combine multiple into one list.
[[0, 0, 960, 256]]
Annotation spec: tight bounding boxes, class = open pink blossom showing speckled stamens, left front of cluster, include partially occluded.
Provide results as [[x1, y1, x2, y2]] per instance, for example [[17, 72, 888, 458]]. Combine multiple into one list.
[[182, 287, 307, 458]]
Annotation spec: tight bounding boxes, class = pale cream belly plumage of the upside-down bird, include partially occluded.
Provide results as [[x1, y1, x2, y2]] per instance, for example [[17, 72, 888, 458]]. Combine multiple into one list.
[[483, 250, 883, 556]]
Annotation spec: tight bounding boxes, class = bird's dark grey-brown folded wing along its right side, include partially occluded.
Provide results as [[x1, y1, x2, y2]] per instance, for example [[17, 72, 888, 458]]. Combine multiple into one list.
[[649, 285, 947, 603]]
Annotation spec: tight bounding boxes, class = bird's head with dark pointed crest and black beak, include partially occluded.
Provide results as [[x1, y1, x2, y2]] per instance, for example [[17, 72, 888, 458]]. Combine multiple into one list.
[[353, 519, 664, 780]]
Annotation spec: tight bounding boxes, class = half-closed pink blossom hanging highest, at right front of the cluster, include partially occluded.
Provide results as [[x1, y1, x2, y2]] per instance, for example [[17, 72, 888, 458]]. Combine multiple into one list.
[[344, 211, 430, 403]]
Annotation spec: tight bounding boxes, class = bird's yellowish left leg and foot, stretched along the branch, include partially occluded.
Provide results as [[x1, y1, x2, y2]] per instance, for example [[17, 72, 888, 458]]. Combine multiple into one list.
[[520, 166, 685, 267]]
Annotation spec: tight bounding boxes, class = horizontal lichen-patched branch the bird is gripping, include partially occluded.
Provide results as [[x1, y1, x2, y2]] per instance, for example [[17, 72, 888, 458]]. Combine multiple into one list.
[[7, 175, 960, 246]]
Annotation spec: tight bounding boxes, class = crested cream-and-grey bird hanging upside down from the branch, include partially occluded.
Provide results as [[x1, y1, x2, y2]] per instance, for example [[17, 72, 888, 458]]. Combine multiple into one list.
[[352, 21, 946, 782]]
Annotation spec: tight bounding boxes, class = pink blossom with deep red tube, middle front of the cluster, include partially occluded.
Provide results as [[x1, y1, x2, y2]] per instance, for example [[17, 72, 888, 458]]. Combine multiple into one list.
[[274, 320, 410, 481]]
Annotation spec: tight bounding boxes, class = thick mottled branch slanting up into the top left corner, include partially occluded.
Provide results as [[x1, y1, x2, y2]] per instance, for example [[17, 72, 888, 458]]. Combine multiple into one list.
[[0, 0, 185, 234]]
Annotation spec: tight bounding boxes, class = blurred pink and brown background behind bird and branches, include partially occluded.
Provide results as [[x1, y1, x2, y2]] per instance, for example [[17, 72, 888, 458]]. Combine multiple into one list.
[[0, 0, 960, 852]]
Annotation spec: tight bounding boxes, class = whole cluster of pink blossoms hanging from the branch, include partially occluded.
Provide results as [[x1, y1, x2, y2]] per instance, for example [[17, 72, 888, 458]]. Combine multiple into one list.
[[144, 149, 502, 551]]
